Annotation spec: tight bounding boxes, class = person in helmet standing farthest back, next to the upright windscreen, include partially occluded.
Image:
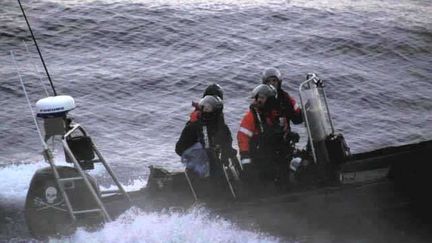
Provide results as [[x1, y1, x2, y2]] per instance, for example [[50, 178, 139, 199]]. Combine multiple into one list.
[[262, 68, 303, 139]]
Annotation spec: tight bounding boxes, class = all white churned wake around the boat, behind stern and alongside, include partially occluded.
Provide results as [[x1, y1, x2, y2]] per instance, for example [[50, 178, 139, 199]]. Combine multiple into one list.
[[0, 161, 280, 242]]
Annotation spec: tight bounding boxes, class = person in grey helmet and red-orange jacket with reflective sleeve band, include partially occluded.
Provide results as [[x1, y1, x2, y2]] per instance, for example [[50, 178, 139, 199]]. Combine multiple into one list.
[[237, 84, 286, 181]]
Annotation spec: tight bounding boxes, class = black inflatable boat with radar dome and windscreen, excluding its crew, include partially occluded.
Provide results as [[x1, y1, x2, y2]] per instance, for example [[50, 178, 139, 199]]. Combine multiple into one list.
[[25, 74, 432, 238]]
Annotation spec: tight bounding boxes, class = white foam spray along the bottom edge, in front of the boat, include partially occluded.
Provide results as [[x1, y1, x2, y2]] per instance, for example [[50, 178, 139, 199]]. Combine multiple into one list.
[[51, 208, 279, 243]]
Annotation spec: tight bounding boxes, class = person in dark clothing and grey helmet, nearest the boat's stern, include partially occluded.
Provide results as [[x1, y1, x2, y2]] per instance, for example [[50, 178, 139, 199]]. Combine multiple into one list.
[[175, 95, 237, 177]]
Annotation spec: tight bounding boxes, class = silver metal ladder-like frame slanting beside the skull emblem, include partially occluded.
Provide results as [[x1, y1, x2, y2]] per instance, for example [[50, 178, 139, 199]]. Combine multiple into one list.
[[45, 124, 131, 222]]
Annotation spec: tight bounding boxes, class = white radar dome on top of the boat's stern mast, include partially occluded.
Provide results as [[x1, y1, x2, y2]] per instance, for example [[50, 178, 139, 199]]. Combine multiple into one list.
[[36, 95, 76, 117]]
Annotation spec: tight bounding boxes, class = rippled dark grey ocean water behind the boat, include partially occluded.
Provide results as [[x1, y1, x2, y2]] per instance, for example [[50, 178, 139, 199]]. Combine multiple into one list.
[[0, 0, 432, 241]]
